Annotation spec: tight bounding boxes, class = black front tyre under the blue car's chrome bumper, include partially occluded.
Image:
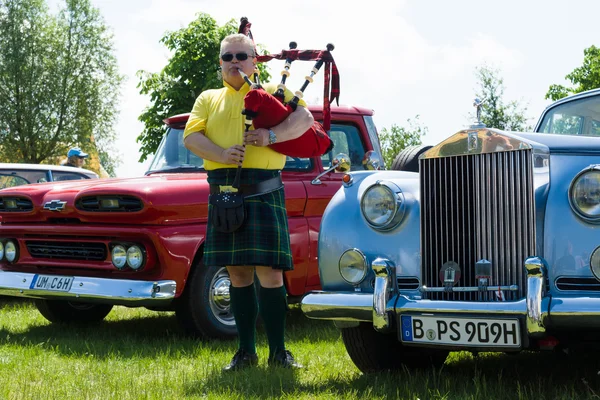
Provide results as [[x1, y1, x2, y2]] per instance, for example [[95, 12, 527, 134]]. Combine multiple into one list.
[[342, 323, 448, 373]]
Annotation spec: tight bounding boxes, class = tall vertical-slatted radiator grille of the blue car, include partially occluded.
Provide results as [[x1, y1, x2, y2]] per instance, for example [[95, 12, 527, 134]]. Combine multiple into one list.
[[420, 150, 535, 301]]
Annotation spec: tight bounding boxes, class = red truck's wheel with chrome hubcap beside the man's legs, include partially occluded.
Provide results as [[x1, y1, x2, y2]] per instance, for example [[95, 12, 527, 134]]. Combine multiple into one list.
[[175, 262, 237, 339]]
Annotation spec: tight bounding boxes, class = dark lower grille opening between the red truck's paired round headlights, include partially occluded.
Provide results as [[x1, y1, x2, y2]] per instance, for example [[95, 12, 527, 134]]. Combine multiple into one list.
[[25, 240, 107, 261]]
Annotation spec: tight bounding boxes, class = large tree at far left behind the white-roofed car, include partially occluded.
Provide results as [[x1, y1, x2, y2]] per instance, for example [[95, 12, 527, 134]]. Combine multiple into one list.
[[0, 0, 122, 174]]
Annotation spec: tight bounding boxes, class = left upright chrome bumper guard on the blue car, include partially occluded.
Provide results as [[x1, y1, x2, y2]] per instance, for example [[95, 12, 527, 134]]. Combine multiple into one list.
[[371, 258, 398, 332]]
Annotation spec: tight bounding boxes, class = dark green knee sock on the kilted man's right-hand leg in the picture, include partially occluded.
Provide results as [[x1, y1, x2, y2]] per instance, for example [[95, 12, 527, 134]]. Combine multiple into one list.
[[258, 286, 287, 355]]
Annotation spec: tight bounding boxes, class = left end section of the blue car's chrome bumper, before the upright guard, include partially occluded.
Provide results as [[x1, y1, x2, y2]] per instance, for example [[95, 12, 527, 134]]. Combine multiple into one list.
[[300, 292, 373, 322]]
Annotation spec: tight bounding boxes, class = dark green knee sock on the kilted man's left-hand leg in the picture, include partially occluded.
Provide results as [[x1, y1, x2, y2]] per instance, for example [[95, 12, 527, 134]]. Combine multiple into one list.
[[229, 284, 258, 354]]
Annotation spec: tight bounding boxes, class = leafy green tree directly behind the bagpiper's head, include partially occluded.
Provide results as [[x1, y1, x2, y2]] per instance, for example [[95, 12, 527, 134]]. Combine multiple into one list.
[[137, 13, 270, 162]]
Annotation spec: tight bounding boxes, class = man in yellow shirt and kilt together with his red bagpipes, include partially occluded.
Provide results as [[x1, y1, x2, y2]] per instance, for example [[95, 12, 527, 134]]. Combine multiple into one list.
[[184, 18, 339, 371]]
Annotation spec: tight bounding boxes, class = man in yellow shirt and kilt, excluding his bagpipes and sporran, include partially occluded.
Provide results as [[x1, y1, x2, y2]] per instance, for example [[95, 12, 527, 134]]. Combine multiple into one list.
[[184, 34, 313, 371]]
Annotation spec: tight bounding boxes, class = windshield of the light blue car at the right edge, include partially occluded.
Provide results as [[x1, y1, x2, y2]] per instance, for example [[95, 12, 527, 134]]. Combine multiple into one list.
[[538, 96, 600, 136]]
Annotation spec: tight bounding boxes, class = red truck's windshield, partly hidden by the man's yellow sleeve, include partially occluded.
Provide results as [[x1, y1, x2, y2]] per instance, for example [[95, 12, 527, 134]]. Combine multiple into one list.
[[146, 128, 204, 174]]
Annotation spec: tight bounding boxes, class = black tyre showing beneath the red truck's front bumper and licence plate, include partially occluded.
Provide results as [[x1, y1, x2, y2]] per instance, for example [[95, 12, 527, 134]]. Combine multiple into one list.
[[35, 299, 113, 324]]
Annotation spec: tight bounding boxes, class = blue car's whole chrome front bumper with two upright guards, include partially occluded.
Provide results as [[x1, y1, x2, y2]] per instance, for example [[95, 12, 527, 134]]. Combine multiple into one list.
[[301, 257, 600, 337]]
